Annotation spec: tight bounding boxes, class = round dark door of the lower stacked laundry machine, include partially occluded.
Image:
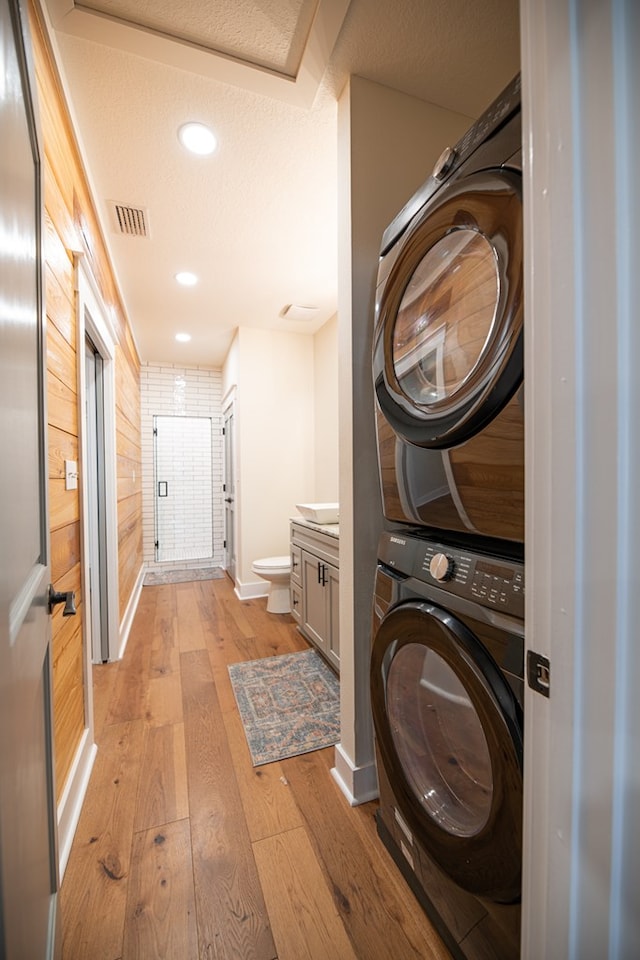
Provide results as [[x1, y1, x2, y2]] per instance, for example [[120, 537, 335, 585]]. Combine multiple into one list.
[[371, 601, 522, 903]]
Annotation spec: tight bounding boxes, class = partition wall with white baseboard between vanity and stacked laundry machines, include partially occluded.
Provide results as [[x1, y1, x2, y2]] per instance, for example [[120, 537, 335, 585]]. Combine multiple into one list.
[[334, 77, 471, 802]]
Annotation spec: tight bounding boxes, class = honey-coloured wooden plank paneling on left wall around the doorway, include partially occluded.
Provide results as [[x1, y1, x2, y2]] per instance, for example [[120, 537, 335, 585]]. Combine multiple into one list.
[[29, 0, 142, 808]]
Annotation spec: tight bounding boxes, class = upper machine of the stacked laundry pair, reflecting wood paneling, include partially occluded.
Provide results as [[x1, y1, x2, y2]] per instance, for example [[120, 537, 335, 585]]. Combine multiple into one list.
[[373, 77, 524, 543]]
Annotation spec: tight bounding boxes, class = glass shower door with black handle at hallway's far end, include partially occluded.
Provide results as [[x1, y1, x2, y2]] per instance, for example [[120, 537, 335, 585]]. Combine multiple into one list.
[[153, 416, 213, 561]]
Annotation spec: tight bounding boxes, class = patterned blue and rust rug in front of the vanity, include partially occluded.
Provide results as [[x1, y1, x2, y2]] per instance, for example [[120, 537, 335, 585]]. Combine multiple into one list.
[[229, 650, 340, 767]]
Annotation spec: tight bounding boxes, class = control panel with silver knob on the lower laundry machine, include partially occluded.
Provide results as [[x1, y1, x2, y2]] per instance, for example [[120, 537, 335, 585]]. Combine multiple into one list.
[[378, 532, 524, 620]]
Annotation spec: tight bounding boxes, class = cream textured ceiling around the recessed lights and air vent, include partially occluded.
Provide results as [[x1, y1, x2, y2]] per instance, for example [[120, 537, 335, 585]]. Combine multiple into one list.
[[45, 0, 519, 366]]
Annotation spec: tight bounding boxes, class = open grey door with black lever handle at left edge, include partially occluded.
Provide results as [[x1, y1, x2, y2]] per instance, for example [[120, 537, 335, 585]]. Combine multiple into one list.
[[0, 0, 58, 960]]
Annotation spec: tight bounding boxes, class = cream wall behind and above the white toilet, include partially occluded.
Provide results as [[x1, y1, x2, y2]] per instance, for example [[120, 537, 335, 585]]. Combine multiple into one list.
[[223, 327, 315, 598]]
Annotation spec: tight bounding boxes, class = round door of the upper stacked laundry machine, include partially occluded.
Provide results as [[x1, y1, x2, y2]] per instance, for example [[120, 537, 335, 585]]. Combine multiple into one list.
[[373, 169, 523, 449]]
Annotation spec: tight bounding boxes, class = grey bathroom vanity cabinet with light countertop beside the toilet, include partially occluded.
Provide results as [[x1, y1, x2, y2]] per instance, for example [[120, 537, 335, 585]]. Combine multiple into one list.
[[290, 519, 340, 671]]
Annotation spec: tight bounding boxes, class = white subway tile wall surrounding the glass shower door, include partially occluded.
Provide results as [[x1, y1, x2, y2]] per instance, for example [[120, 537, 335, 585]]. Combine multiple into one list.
[[140, 363, 224, 570]]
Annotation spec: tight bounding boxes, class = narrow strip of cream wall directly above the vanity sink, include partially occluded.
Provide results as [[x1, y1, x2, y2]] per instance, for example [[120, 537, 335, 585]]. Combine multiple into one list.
[[312, 315, 339, 503]]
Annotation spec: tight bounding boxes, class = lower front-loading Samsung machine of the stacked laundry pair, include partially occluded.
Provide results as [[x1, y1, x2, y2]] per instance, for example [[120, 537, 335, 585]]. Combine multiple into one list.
[[371, 528, 524, 960]]
